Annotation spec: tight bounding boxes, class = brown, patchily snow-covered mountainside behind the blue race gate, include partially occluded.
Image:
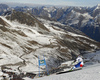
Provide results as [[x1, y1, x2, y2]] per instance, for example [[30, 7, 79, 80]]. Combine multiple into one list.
[[0, 11, 100, 79]]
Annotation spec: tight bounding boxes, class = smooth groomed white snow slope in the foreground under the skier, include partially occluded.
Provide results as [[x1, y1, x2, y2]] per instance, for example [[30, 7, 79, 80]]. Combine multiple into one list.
[[25, 51, 100, 80]]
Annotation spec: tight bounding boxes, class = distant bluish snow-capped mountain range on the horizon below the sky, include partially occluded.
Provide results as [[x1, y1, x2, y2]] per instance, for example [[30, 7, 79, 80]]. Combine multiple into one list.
[[0, 4, 100, 42]]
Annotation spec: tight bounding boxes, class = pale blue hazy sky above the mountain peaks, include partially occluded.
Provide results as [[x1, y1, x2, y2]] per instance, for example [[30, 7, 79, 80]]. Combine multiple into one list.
[[0, 0, 100, 6]]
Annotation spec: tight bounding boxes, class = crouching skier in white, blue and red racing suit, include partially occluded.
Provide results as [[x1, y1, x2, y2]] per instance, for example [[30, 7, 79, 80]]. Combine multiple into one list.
[[71, 55, 84, 70]]
